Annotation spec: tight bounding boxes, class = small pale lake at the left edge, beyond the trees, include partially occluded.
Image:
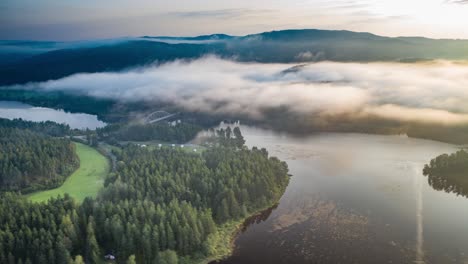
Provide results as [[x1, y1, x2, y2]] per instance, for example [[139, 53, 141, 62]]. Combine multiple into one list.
[[0, 101, 106, 130]]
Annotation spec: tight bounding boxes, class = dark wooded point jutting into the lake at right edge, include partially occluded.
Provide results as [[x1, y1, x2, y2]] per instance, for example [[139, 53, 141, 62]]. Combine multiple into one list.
[[423, 150, 468, 197]]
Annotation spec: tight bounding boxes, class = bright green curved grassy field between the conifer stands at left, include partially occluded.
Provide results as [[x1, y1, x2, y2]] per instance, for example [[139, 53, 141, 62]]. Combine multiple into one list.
[[27, 143, 109, 202]]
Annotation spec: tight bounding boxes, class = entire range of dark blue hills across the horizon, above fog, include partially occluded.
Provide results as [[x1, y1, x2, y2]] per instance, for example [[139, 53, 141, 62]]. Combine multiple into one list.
[[0, 29, 468, 85]]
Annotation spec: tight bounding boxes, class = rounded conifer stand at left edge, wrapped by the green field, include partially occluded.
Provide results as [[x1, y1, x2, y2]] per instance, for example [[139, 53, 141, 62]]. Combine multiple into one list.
[[0, 127, 79, 193]]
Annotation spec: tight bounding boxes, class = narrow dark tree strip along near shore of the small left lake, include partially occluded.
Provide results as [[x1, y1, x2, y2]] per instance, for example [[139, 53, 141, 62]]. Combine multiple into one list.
[[0, 118, 72, 137]]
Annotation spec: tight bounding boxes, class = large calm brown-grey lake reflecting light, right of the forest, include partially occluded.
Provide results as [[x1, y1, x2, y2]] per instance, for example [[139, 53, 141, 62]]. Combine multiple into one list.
[[216, 126, 468, 264]]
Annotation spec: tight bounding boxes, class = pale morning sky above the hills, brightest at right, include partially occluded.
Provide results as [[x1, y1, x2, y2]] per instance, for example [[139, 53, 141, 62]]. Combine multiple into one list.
[[0, 0, 468, 41]]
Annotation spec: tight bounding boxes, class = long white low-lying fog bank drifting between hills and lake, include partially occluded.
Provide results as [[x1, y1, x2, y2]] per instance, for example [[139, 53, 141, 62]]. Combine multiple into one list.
[[8, 57, 468, 125]]
